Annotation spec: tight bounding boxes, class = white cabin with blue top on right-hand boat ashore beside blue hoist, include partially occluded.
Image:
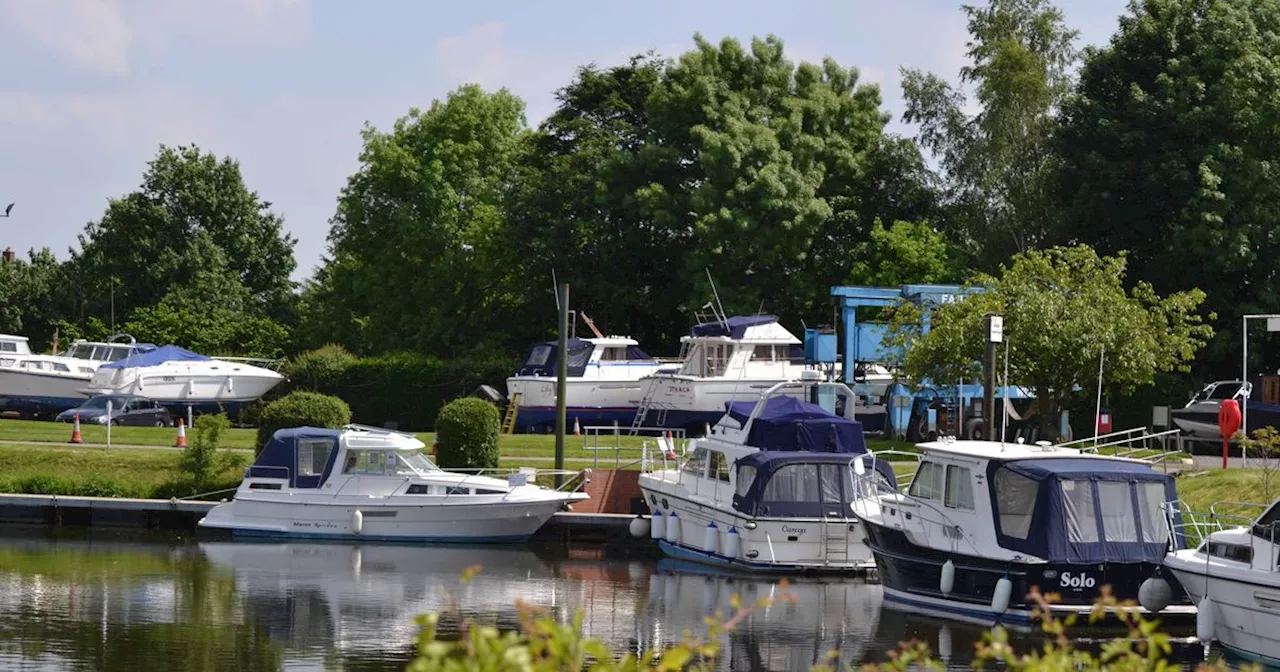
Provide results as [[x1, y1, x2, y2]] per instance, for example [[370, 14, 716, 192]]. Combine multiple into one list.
[[677, 315, 804, 378]]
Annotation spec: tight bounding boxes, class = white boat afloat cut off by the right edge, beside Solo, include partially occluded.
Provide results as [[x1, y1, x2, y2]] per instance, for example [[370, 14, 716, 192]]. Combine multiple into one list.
[[1165, 499, 1280, 667]]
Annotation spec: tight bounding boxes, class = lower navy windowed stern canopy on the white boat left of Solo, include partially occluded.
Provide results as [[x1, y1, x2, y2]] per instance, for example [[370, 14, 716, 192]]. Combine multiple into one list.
[[733, 451, 897, 518]]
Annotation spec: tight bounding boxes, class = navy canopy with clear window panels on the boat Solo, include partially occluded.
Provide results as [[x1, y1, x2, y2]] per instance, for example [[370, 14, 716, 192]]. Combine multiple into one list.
[[987, 457, 1185, 563]]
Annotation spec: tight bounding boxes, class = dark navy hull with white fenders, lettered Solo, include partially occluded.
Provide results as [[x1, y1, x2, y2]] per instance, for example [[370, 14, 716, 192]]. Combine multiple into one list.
[[864, 520, 1194, 623]]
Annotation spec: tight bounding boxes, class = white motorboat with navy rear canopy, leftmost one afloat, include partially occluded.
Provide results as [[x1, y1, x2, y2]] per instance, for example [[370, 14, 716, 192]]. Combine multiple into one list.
[[198, 425, 588, 543]]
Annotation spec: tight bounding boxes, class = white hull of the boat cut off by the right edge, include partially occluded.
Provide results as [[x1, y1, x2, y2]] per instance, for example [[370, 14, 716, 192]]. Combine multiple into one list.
[[1165, 550, 1280, 664]]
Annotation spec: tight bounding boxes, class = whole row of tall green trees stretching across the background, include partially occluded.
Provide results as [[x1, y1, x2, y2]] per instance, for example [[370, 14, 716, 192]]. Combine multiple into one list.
[[0, 0, 1280, 404]]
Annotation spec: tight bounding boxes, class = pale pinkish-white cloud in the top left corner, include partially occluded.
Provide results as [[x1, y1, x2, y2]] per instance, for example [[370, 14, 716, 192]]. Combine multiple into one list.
[[5, 0, 133, 74]]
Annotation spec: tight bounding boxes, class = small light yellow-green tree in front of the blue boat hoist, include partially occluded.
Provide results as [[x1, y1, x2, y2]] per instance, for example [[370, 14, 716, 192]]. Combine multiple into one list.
[[890, 246, 1213, 433]]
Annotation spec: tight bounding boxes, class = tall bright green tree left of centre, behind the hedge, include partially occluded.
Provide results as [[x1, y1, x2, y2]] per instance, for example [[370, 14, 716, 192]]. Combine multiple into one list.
[[317, 84, 526, 356]]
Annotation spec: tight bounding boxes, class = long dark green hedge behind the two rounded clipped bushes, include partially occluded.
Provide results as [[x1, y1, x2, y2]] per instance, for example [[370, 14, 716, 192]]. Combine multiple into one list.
[[282, 348, 520, 431]]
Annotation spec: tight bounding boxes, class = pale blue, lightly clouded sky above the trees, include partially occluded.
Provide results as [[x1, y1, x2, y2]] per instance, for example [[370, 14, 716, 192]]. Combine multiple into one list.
[[0, 0, 1126, 280]]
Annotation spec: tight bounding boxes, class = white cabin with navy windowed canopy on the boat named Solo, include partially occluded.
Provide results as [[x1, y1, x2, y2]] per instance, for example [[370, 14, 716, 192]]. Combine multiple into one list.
[[885, 442, 1181, 563]]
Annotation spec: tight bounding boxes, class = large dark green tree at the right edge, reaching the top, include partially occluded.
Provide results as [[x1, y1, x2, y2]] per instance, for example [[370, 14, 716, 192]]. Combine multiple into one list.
[[1057, 0, 1280, 370]]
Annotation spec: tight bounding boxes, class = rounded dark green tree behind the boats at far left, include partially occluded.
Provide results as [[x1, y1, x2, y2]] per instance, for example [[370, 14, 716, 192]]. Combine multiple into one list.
[[69, 146, 294, 325]]
